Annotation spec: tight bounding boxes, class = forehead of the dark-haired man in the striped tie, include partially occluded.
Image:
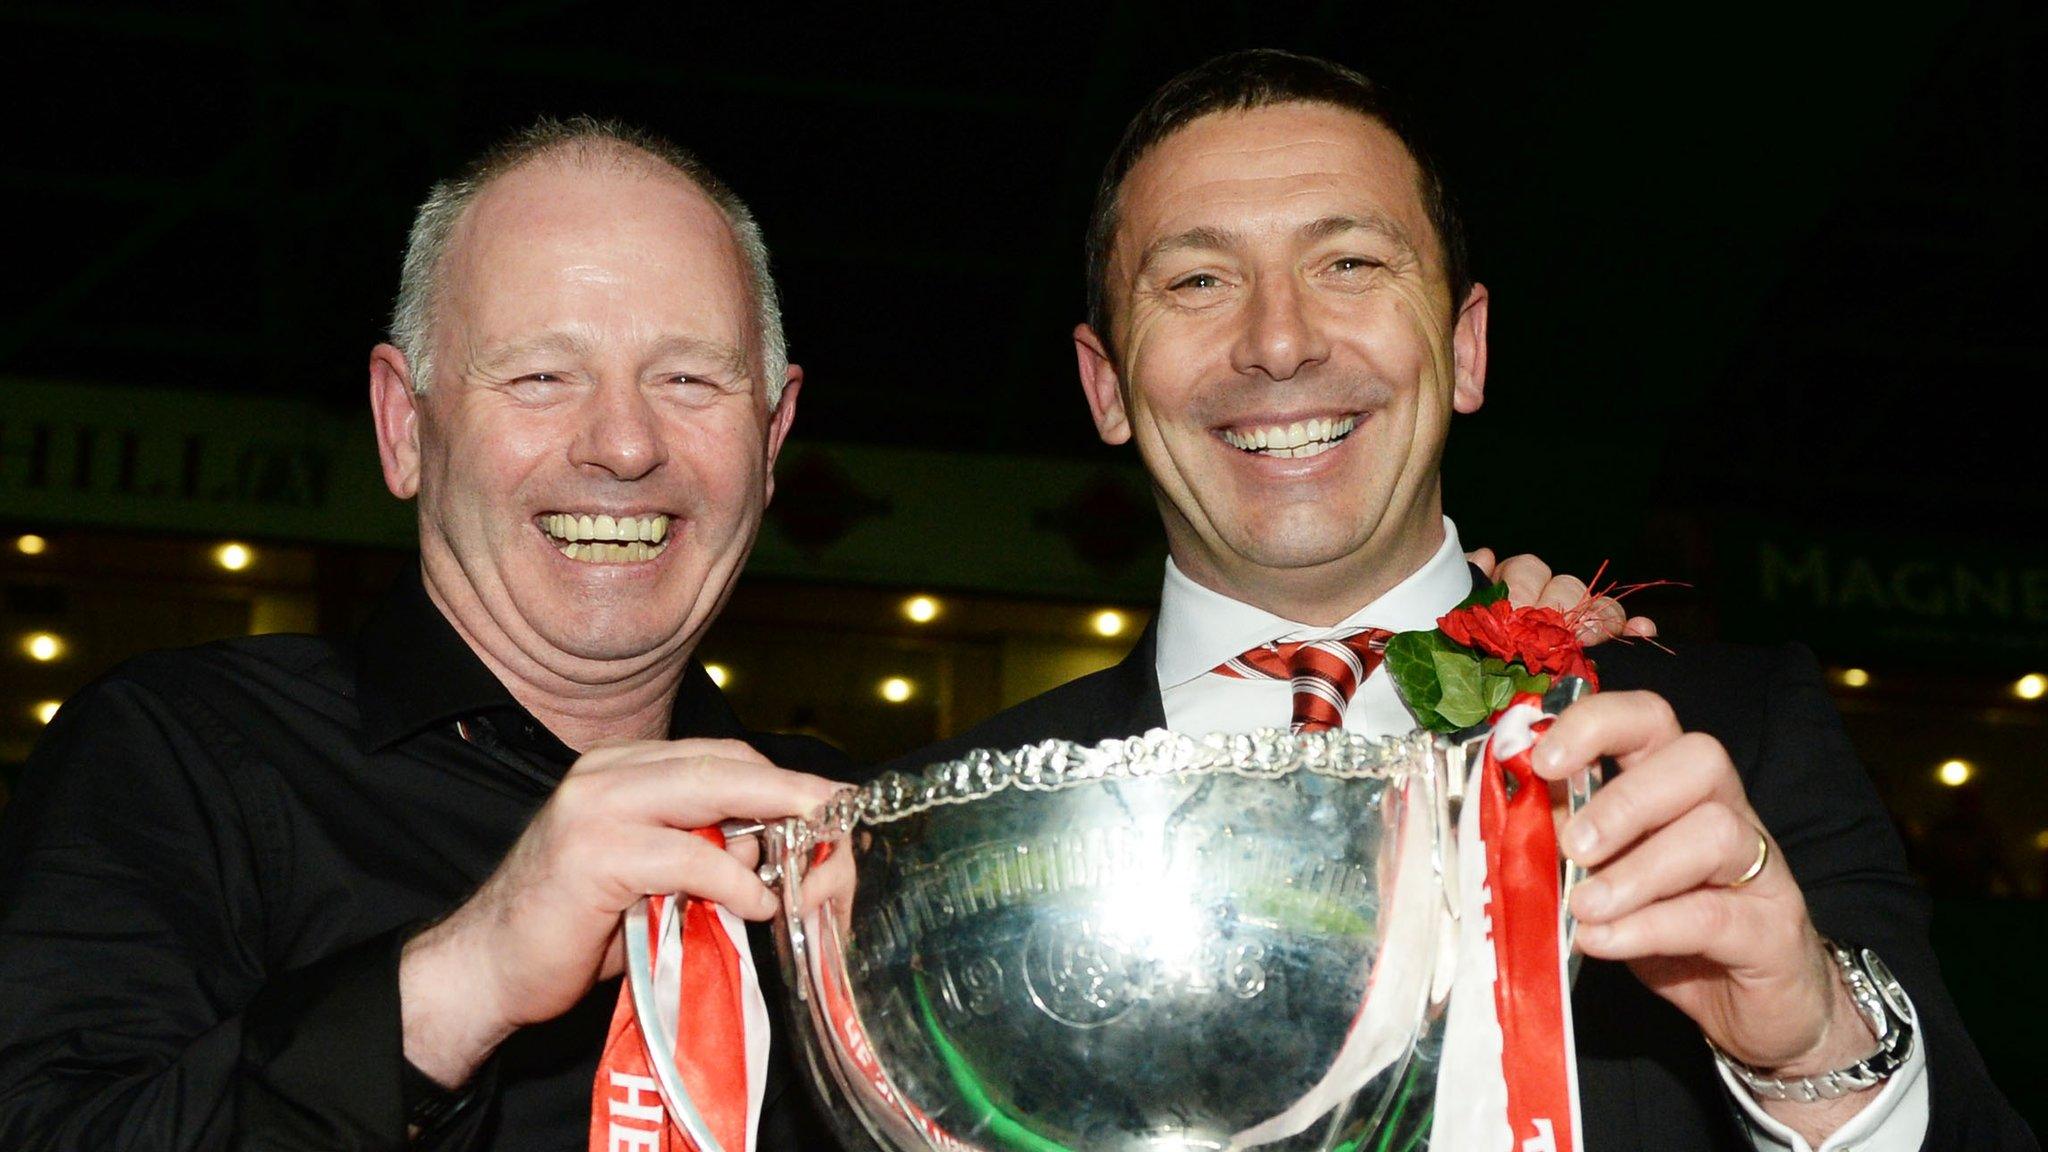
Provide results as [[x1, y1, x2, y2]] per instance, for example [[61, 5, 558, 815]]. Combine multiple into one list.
[[1112, 102, 1442, 275]]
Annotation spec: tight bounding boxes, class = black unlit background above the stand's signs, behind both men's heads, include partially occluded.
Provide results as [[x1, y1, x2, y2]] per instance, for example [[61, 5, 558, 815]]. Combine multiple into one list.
[[0, 0, 2048, 560]]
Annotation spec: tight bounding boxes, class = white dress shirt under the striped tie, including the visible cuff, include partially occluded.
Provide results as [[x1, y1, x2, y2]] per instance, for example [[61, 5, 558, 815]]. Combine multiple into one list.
[[1157, 517, 1927, 1152]]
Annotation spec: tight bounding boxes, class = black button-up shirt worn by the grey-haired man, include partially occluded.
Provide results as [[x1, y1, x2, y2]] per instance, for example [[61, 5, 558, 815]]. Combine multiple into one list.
[[0, 570, 850, 1152]]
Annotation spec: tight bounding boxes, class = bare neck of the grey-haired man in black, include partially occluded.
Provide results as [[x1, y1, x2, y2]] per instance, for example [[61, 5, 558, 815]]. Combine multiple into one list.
[[426, 572, 690, 752]]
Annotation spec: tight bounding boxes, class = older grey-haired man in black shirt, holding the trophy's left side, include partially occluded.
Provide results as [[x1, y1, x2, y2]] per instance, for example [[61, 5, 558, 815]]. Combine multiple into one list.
[[0, 121, 848, 1150]]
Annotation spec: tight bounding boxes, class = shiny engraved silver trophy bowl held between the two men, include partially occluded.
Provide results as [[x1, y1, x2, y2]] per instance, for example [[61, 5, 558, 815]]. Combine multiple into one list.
[[625, 681, 1591, 1152]]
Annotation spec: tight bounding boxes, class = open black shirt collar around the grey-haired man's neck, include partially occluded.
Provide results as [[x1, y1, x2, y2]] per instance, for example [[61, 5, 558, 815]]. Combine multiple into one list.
[[356, 564, 741, 767]]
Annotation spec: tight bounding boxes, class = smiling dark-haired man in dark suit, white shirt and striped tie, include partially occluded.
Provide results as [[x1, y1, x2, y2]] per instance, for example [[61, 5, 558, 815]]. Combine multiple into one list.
[[897, 51, 2036, 1150]]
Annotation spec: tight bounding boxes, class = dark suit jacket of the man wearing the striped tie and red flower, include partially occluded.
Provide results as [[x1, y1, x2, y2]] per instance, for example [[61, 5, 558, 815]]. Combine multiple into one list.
[[891, 629, 2040, 1152]]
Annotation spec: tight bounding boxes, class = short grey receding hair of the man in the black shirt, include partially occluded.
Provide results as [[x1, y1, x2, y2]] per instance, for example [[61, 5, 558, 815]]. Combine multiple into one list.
[[391, 117, 788, 408]]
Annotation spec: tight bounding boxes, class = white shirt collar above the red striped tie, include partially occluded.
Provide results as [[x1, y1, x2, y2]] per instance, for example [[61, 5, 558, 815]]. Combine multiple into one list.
[[1157, 517, 1473, 689]]
